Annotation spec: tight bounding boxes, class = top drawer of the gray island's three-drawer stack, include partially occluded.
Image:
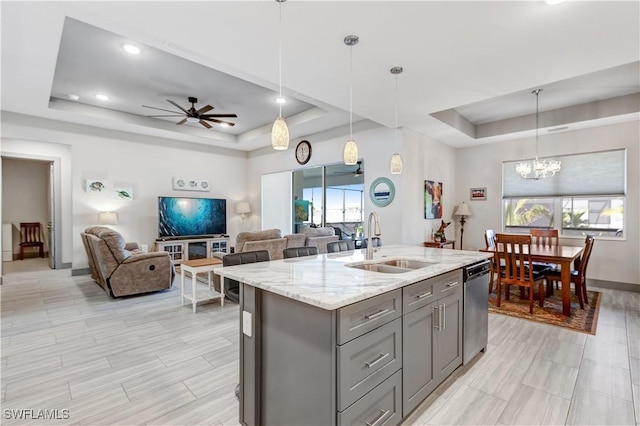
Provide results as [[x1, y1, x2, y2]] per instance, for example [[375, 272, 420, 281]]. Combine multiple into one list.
[[337, 289, 402, 345]]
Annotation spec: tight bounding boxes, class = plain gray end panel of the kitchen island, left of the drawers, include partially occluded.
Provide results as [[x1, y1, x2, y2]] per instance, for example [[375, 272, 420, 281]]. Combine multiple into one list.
[[259, 291, 336, 426]]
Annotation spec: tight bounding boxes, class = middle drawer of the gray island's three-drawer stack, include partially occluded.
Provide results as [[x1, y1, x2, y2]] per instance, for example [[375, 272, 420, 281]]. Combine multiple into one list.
[[337, 318, 402, 411]]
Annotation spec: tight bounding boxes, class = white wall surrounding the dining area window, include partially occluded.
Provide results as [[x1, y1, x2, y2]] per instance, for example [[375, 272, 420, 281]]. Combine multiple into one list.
[[456, 121, 640, 284]]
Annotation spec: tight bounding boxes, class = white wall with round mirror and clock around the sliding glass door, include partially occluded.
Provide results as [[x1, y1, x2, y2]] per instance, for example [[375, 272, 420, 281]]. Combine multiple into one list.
[[248, 127, 456, 245]]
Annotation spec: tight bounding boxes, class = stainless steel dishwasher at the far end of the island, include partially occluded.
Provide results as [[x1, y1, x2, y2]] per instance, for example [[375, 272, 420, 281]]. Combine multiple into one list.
[[462, 260, 491, 364]]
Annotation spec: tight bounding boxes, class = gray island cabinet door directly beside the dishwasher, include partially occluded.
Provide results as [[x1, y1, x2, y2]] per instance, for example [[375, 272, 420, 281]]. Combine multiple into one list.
[[433, 287, 462, 383]]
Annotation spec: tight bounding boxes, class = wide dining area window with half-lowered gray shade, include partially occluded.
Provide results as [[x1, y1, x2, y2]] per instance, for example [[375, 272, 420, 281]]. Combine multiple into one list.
[[503, 149, 626, 238]]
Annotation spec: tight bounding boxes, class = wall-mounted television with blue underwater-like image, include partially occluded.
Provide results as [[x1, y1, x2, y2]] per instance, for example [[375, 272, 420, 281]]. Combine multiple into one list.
[[158, 197, 227, 237]]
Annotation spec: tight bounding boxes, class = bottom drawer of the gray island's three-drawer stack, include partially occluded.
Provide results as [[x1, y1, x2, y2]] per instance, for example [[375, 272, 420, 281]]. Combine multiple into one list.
[[338, 371, 402, 426]]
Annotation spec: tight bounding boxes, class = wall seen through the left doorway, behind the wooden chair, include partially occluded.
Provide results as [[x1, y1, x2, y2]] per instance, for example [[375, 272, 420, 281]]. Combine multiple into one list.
[[2, 158, 49, 254]]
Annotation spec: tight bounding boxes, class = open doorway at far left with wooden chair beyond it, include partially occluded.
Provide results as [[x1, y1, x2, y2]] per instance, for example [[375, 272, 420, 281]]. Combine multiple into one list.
[[2, 156, 56, 275]]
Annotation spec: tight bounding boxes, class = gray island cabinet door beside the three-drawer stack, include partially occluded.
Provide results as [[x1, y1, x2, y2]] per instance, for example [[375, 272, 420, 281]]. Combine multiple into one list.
[[402, 303, 438, 417]]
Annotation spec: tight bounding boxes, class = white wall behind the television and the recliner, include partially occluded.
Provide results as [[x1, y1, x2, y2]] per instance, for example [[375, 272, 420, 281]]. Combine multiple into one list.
[[2, 116, 247, 269]]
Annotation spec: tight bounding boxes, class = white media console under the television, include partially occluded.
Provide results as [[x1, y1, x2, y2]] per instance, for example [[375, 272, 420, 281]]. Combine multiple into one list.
[[154, 236, 230, 264]]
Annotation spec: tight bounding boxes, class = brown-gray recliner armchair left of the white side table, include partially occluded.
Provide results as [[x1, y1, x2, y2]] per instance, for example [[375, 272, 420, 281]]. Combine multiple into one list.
[[81, 226, 175, 297]]
